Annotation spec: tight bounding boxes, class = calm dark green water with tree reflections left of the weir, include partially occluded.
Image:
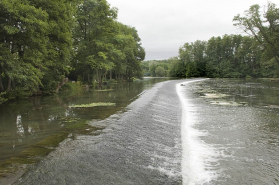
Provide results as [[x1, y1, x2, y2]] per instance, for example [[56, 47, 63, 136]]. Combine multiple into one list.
[[0, 78, 170, 169]]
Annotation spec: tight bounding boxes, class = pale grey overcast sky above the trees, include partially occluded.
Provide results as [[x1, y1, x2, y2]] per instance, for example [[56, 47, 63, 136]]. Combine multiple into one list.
[[107, 0, 278, 60]]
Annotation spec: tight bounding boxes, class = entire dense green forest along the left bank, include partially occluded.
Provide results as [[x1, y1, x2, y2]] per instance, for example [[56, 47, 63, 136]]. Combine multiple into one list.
[[0, 0, 145, 102]]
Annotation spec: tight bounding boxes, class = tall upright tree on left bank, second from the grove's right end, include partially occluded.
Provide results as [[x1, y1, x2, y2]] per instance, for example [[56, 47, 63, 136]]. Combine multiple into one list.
[[73, 0, 117, 84]]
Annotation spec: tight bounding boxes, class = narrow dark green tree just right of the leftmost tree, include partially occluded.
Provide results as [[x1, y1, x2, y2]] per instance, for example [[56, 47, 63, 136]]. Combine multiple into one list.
[[29, 0, 80, 93]]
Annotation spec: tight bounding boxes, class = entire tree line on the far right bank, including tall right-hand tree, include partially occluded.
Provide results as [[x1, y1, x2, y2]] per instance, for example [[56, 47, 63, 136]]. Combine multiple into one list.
[[144, 3, 279, 78]]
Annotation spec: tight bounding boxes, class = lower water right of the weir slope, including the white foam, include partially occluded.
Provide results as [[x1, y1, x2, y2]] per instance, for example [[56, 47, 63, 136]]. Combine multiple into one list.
[[177, 79, 279, 185]]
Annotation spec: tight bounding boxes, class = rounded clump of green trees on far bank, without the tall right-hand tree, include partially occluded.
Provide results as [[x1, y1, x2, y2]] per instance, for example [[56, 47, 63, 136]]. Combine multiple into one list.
[[171, 35, 277, 78]]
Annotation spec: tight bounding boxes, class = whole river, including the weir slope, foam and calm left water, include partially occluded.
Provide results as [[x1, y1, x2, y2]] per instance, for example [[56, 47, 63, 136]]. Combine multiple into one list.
[[0, 79, 279, 185]]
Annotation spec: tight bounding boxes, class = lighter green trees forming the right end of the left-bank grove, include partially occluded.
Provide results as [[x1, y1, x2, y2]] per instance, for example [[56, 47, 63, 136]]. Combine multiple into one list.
[[71, 0, 145, 85]]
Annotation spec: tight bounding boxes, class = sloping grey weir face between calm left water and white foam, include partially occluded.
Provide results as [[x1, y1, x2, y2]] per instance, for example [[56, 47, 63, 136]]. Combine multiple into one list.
[[15, 81, 186, 185]]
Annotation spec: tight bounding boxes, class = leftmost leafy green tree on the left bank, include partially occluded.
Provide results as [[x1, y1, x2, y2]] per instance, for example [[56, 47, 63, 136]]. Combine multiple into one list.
[[0, 0, 48, 97]]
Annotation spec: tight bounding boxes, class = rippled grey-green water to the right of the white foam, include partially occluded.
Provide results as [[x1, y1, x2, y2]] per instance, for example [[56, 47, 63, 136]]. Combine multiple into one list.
[[188, 80, 279, 185]]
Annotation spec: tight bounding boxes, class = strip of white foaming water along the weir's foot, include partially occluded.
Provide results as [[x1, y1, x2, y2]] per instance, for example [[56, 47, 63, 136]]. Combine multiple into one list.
[[176, 81, 217, 185]]
